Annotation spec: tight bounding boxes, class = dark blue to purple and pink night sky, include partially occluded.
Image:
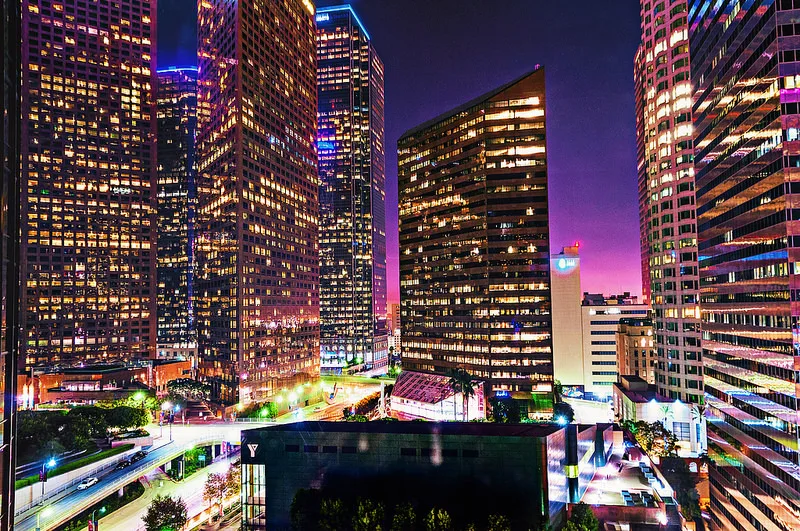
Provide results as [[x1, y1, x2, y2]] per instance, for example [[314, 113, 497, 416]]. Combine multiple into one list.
[[158, 0, 641, 302]]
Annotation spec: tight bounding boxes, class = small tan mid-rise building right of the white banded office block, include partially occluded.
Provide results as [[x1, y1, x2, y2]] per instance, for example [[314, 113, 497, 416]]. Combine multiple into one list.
[[616, 317, 658, 384]]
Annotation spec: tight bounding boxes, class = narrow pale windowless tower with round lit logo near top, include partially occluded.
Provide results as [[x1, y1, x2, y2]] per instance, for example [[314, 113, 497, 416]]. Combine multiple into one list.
[[550, 245, 584, 387]]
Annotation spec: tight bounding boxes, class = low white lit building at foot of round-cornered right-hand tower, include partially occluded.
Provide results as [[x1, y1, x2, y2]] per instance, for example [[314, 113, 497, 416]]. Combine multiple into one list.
[[613, 375, 707, 456]]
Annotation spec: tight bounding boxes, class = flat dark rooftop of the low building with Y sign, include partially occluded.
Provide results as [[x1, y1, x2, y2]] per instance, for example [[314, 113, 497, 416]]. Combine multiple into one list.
[[242, 420, 564, 438]]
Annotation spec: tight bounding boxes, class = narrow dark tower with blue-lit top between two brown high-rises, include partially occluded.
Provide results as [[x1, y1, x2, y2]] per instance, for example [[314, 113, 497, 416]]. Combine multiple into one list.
[[157, 67, 197, 357]]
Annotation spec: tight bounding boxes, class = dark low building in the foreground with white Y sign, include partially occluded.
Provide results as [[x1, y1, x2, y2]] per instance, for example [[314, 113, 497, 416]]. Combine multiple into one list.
[[242, 422, 611, 530]]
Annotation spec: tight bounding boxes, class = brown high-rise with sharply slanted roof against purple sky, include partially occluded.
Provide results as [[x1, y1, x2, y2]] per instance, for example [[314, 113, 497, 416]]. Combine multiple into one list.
[[398, 67, 553, 398]]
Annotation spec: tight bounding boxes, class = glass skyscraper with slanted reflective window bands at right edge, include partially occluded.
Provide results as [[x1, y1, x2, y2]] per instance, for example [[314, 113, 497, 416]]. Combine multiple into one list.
[[689, 0, 800, 531]]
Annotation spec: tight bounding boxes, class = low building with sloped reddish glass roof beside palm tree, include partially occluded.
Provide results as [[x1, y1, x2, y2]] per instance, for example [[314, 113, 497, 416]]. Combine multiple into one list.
[[392, 371, 486, 421]]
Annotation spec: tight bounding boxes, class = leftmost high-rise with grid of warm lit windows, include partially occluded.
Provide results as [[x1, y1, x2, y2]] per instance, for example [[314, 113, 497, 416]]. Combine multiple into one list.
[[20, 0, 156, 367]]
